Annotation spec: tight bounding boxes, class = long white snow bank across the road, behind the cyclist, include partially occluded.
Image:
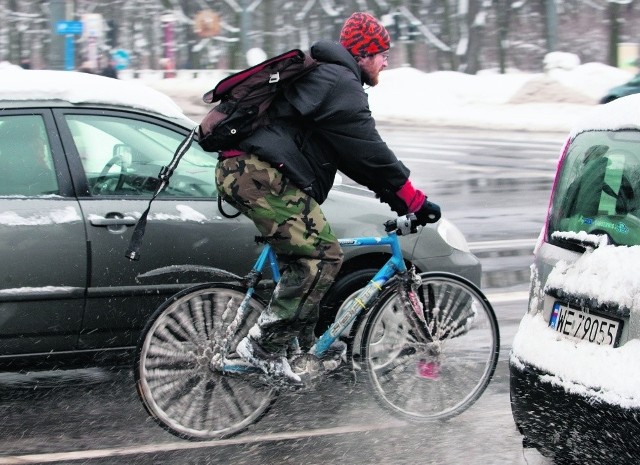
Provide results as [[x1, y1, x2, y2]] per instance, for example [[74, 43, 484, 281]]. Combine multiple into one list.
[[0, 57, 632, 132]]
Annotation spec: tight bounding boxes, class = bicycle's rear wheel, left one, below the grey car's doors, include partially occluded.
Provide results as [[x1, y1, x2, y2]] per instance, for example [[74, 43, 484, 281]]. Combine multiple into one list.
[[134, 283, 277, 440]]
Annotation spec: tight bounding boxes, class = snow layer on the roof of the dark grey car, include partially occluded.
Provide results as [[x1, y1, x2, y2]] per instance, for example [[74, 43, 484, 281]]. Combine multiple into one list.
[[0, 69, 187, 120]]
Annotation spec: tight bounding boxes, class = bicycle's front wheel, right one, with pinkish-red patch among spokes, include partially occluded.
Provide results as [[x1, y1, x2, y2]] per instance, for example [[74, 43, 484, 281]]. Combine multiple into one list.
[[361, 273, 500, 422]]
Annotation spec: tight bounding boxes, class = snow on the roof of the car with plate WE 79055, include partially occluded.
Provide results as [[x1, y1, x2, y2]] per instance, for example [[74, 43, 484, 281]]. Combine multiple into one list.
[[571, 94, 640, 137]]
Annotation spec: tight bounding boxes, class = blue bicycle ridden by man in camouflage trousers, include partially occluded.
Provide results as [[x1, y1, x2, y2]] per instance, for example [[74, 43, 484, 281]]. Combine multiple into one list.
[[135, 215, 500, 440]]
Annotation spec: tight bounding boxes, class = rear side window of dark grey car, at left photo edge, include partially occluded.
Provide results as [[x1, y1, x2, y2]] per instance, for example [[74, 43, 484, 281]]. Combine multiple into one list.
[[0, 115, 59, 197]]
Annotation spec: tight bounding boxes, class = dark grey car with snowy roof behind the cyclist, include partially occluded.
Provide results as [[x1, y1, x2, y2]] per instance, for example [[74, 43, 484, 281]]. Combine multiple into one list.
[[0, 70, 481, 369]]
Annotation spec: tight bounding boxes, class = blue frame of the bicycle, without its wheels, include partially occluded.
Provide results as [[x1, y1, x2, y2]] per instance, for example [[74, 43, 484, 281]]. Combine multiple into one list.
[[222, 227, 407, 373]]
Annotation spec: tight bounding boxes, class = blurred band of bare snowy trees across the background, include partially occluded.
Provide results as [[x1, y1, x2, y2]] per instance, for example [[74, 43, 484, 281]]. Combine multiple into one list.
[[0, 0, 640, 74]]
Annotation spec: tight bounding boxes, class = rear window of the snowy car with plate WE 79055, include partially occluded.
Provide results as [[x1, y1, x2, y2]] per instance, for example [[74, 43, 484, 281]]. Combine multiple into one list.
[[547, 130, 640, 246]]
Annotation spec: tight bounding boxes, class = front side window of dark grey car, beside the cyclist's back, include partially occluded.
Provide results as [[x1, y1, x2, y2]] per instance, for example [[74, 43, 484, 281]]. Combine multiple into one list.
[[65, 114, 217, 198]]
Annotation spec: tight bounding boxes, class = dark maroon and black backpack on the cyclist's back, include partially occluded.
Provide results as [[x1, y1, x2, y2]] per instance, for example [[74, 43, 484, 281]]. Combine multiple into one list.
[[198, 49, 318, 152]]
